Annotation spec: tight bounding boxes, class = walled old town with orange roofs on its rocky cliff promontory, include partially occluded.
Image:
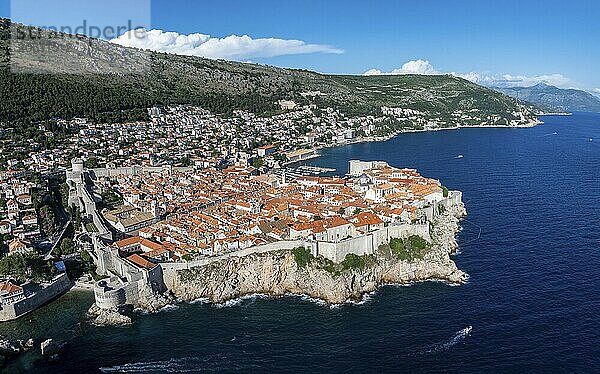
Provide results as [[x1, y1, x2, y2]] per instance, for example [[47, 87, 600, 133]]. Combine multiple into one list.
[[67, 159, 467, 324]]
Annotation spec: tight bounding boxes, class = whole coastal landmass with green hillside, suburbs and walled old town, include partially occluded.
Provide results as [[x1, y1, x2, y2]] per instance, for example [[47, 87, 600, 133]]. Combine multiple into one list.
[[0, 19, 524, 319]]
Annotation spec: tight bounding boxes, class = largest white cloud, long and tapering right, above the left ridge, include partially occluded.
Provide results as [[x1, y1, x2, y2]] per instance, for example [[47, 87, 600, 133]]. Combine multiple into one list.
[[111, 29, 344, 61]]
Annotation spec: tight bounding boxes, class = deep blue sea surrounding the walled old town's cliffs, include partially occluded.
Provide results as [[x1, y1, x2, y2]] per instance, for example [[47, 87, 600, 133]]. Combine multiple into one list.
[[0, 113, 600, 374]]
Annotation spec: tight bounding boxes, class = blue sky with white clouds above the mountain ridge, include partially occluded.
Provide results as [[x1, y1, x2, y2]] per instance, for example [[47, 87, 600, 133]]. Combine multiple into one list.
[[0, 0, 600, 92]]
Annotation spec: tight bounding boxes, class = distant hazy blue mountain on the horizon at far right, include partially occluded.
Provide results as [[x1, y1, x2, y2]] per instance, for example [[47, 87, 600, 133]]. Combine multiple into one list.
[[493, 83, 600, 113]]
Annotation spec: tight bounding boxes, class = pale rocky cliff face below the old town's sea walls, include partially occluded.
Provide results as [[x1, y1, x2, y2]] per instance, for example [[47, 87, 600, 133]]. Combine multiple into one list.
[[166, 206, 468, 304]]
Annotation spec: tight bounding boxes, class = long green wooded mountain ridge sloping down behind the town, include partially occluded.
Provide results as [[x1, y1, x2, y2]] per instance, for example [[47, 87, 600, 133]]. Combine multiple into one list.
[[0, 19, 529, 127]]
